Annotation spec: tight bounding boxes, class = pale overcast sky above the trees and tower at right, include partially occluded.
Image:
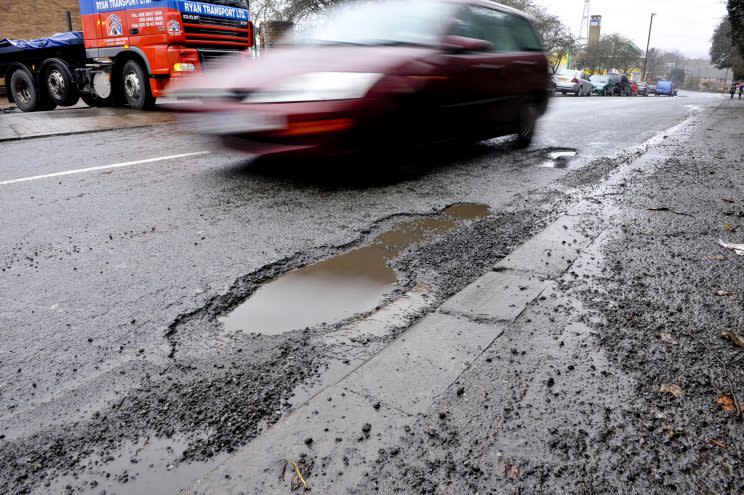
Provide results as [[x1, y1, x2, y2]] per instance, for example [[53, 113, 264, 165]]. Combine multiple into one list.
[[539, 0, 726, 57]]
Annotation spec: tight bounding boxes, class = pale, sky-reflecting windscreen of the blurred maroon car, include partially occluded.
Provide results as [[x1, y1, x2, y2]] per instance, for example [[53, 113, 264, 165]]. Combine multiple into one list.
[[293, 0, 457, 45]]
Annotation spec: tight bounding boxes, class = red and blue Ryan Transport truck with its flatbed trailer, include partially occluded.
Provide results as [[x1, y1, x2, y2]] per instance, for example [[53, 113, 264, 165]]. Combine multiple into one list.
[[0, 0, 254, 112]]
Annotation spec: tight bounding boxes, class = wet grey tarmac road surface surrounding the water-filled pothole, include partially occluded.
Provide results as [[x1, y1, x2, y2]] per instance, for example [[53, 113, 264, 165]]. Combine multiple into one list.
[[0, 93, 722, 493]]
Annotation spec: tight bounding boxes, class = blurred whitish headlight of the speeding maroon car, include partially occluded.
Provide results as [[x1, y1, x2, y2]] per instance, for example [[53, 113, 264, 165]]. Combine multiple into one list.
[[243, 72, 382, 103]]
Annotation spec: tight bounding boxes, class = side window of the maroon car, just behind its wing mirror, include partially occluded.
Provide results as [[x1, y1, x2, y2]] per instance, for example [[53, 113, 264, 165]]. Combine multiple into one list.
[[453, 6, 518, 52]]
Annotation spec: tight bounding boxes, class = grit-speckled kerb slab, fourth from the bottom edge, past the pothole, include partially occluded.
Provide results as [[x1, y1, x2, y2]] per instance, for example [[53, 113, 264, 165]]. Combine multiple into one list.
[[496, 215, 599, 277]]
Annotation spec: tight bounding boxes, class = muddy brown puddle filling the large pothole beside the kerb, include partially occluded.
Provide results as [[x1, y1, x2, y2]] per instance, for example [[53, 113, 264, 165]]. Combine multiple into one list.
[[219, 204, 489, 335]]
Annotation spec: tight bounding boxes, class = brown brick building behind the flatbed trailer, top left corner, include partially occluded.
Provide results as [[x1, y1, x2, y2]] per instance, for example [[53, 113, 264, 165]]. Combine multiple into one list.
[[0, 0, 82, 39]]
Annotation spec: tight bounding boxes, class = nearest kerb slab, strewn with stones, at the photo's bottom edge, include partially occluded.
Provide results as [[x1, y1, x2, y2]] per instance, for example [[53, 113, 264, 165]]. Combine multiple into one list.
[[181, 387, 411, 495]]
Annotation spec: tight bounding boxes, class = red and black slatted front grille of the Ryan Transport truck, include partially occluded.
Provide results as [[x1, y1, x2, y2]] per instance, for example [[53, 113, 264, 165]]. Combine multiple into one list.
[[183, 15, 252, 48]]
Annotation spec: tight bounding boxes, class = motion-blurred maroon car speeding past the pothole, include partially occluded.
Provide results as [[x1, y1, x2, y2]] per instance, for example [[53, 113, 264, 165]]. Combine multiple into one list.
[[172, 0, 550, 160]]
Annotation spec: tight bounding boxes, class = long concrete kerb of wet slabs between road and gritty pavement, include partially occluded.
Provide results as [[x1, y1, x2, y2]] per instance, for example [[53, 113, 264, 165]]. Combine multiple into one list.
[[182, 109, 696, 494]]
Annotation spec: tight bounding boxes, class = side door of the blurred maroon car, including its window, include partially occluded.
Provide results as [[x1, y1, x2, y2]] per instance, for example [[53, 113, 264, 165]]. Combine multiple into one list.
[[452, 5, 516, 135]]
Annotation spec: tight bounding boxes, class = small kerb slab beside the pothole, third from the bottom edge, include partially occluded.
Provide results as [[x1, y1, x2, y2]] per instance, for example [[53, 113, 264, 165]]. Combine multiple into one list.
[[440, 270, 548, 322]]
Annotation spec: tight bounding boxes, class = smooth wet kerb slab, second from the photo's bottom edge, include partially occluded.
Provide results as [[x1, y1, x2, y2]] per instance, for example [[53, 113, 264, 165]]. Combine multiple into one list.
[[339, 313, 504, 414]]
